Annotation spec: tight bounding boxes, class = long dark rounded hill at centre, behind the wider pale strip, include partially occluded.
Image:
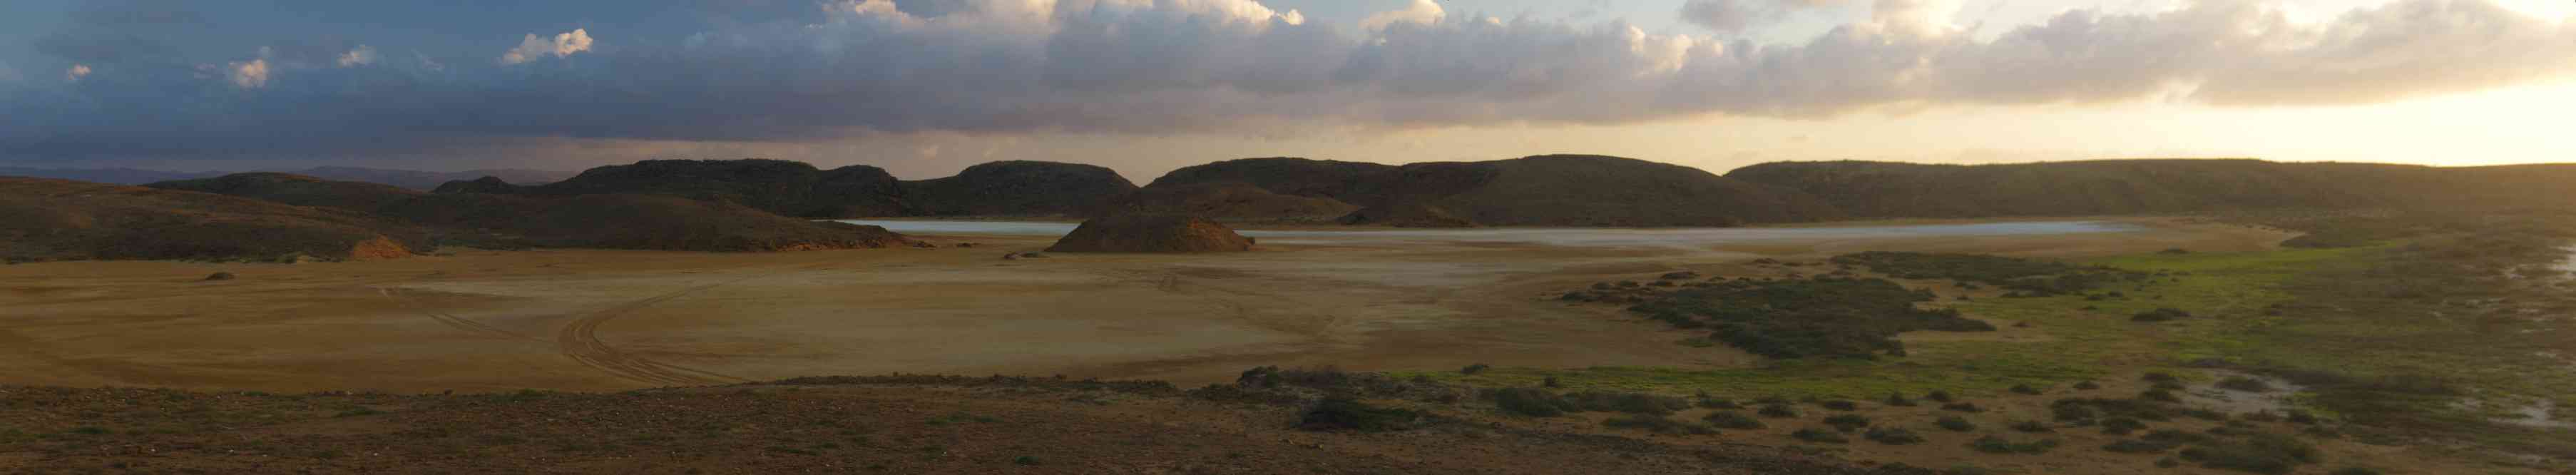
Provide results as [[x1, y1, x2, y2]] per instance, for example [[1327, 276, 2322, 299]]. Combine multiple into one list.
[[1141, 155, 1842, 228]]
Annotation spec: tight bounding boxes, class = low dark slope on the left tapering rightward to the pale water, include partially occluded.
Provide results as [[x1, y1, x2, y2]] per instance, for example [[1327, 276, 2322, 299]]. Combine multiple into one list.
[[152, 173, 904, 250]]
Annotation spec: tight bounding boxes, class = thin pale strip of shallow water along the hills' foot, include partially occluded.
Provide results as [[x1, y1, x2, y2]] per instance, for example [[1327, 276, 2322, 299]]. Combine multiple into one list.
[[840, 220, 2146, 247]]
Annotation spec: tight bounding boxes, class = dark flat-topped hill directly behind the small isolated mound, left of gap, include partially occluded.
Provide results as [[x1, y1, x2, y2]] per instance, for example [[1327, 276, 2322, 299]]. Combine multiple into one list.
[[904, 160, 1136, 217]]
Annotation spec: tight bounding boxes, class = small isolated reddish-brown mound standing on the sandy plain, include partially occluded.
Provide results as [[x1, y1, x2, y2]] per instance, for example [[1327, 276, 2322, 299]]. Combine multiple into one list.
[[1046, 214, 1252, 253]]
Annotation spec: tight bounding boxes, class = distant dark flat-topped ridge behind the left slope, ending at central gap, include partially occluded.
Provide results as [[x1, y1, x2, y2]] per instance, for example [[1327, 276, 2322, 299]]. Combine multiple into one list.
[[521, 160, 1136, 217]]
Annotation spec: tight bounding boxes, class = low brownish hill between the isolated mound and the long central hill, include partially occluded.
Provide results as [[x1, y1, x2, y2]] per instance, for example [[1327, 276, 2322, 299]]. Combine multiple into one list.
[[1110, 180, 1360, 222]]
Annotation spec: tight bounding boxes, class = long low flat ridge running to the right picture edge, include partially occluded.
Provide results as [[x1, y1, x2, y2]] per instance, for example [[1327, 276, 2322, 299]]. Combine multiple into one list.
[[1726, 160, 2576, 217]]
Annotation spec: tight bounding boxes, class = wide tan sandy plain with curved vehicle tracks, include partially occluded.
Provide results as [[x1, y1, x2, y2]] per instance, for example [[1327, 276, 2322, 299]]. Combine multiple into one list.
[[0, 220, 2285, 392]]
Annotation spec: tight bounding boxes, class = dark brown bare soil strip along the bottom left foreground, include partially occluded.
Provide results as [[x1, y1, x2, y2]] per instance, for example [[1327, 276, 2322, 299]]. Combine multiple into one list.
[[0, 377, 1896, 475]]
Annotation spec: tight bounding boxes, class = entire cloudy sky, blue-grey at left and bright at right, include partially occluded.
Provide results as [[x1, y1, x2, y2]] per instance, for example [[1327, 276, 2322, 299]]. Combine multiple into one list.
[[0, 0, 2576, 183]]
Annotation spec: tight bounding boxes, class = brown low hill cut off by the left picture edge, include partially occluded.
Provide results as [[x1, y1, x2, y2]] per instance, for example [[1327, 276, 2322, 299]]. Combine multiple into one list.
[[0, 178, 428, 261]]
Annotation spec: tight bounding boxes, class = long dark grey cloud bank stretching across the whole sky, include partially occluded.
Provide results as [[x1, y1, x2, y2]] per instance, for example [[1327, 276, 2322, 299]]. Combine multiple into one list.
[[0, 0, 2576, 160]]
